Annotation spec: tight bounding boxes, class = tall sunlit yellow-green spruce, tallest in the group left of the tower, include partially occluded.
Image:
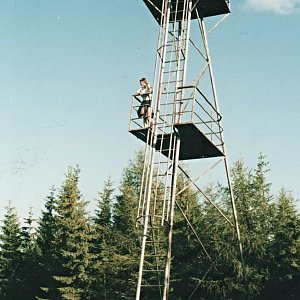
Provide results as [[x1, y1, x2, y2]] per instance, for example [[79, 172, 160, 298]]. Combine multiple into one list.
[[53, 167, 90, 300]]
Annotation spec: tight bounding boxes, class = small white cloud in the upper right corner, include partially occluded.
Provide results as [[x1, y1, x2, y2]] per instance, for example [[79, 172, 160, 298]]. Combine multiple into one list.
[[246, 0, 300, 15]]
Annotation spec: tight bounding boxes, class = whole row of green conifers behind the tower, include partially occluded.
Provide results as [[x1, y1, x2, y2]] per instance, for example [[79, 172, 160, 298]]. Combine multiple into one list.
[[0, 151, 300, 300]]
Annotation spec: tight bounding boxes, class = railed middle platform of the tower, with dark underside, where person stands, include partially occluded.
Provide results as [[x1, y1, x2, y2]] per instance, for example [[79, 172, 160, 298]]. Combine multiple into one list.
[[129, 86, 224, 160]]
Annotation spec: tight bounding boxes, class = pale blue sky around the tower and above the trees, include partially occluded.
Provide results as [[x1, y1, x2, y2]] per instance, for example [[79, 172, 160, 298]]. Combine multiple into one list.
[[0, 0, 300, 219]]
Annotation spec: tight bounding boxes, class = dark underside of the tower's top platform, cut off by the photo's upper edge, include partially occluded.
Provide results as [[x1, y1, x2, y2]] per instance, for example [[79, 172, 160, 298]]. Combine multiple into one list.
[[143, 0, 230, 23]]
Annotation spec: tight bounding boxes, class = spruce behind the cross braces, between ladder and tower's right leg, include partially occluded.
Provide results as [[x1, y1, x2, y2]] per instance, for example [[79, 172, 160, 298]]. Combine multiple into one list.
[[180, 186, 244, 299]]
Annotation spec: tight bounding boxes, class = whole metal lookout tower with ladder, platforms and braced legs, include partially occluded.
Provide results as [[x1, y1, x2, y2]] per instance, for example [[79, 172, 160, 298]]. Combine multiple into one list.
[[129, 0, 247, 299]]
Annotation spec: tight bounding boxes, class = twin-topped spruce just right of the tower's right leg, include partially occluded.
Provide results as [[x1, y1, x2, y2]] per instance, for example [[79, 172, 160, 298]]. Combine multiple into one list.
[[233, 155, 275, 297]]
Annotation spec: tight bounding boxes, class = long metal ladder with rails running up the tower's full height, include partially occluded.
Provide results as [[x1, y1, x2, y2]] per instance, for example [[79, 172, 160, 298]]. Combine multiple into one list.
[[136, 0, 191, 299]]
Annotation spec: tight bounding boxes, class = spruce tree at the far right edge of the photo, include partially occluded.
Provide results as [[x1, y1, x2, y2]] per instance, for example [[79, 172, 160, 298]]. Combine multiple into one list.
[[262, 189, 300, 299]]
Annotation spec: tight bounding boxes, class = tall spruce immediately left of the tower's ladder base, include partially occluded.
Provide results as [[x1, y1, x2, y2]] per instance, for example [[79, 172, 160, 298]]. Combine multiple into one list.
[[113, 151, 143, 299]]
